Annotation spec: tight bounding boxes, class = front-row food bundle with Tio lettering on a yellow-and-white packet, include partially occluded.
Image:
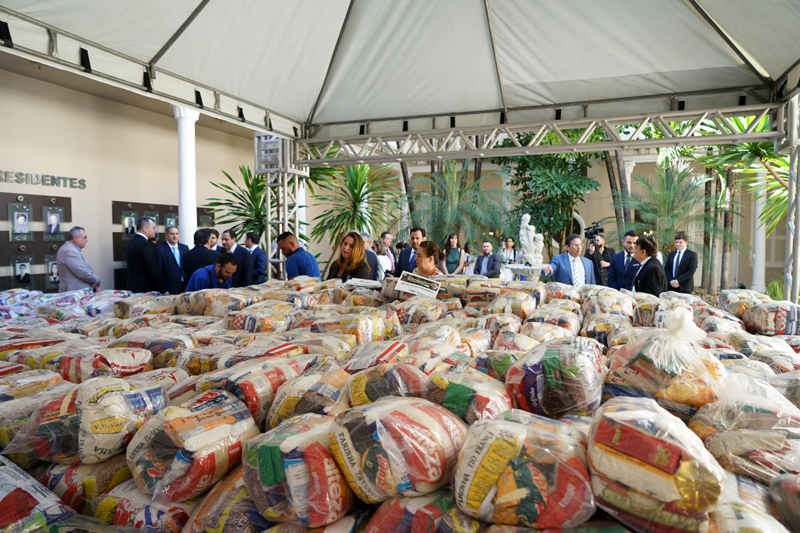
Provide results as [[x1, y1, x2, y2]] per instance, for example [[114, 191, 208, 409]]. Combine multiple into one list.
[[452, 412, 596, 530]]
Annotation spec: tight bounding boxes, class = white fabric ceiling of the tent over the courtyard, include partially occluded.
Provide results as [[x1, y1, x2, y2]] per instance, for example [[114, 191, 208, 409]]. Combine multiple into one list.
[[0, 0, 800, 135]]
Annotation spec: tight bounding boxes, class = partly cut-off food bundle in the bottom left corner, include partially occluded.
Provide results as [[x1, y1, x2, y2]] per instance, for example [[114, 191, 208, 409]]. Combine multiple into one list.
[[0, 450, 75, 533]]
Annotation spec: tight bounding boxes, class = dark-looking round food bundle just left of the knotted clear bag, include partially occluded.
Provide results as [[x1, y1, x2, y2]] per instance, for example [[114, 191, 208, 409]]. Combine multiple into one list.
[[506, 337, 606, 418]]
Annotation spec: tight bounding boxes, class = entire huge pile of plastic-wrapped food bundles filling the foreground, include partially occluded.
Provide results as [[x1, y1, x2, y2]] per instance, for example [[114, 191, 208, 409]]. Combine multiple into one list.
[[0, 275, 800, 533]]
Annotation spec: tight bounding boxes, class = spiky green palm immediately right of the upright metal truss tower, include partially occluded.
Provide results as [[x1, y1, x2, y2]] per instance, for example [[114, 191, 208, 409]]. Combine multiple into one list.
[[311, 165, 401, 247]]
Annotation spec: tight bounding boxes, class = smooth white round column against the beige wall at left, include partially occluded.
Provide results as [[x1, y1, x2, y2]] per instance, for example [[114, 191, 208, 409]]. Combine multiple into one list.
[[172, 105, 200, 248]]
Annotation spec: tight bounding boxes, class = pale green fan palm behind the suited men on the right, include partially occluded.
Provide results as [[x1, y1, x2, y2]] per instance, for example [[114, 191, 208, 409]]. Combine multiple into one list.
[[620, 162, 748, 251]]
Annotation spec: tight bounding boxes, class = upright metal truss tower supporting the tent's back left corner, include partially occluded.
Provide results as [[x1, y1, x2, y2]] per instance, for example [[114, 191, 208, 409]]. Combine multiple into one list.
[[253, 132, 308, 279]]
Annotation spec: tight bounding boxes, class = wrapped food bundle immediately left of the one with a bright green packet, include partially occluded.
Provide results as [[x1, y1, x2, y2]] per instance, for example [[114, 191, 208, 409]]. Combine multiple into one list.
[[127, 391, 259, 503]]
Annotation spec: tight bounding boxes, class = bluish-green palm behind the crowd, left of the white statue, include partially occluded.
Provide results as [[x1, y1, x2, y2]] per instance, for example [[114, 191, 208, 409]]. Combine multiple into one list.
[[398, 160, 512, 250]]
